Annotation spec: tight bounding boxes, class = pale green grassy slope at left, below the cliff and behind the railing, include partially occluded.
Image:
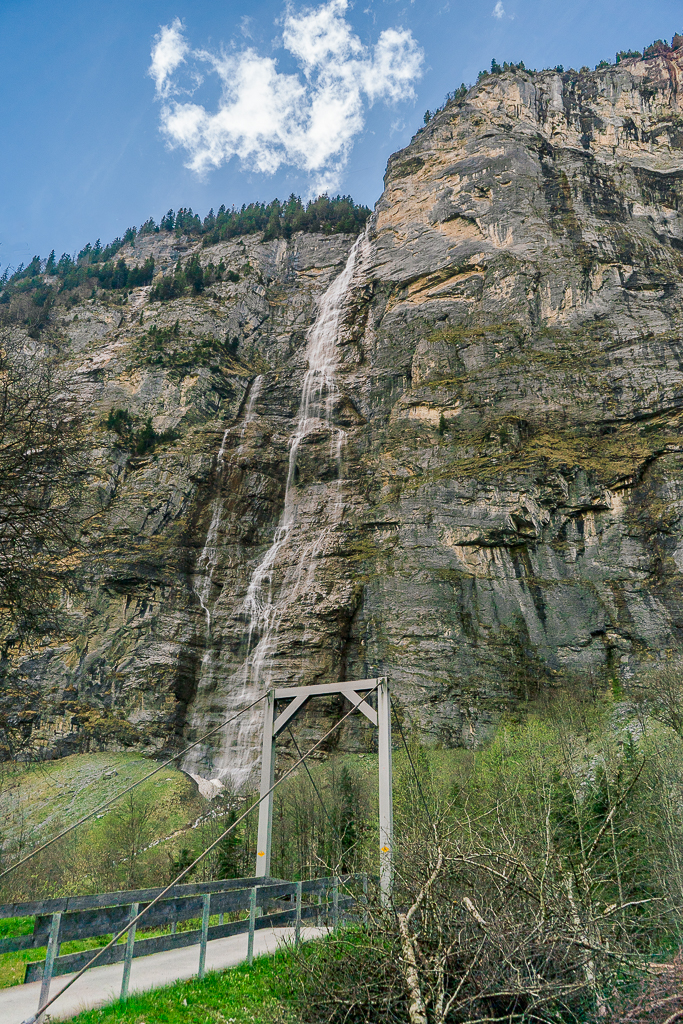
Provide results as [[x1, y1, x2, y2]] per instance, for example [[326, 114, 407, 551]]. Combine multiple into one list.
[[0, 753, 209, 903]]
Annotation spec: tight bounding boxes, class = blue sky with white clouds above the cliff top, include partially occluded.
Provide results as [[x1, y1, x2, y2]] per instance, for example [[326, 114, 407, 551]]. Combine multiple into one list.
[[0, 0, 683, 270]]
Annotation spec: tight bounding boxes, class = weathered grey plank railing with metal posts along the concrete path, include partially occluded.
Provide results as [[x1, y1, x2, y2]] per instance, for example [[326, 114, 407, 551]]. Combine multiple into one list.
[[0, 876, 360, 1008]]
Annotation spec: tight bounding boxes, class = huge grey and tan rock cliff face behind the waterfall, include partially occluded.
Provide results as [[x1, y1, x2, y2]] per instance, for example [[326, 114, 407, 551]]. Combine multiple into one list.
[[14, 54, 683, 777]]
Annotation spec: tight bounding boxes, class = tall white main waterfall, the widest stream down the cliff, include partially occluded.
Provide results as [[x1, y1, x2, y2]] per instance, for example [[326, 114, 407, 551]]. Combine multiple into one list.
[[183, 232, 370, 796]]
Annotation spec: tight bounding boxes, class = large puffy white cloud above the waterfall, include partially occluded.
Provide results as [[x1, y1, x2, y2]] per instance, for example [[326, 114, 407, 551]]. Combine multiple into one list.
[[150, 0, 423, 191]]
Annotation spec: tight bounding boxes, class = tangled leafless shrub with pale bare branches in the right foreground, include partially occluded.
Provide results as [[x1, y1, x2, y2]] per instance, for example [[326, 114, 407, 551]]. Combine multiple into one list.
[[300, 802, 655, 1024]]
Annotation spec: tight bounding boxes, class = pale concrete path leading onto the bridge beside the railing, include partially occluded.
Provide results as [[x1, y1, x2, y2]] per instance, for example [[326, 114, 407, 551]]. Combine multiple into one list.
[[0, 928, 328, 1024]]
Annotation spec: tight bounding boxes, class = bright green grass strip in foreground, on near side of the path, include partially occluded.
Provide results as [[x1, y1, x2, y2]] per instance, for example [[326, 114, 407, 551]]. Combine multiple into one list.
[[65, 950, 299, 1024]]
